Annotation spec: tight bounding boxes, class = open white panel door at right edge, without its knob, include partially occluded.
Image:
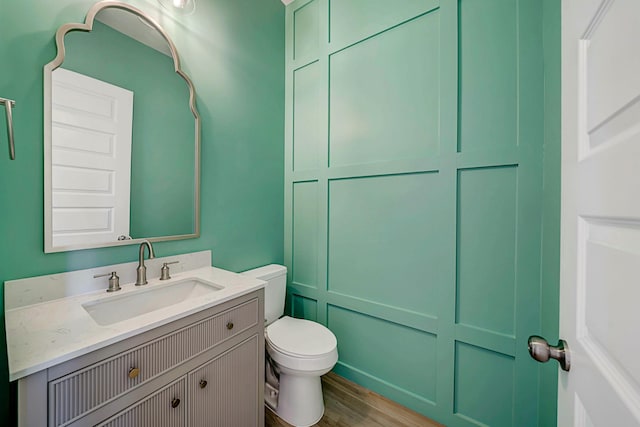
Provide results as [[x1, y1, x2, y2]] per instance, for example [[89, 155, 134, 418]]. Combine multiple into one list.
[[558, 0, 640, 427]]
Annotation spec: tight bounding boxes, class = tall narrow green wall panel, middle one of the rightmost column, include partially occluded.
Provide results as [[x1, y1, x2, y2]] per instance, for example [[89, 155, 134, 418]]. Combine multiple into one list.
[[456, 167, 518, 335]]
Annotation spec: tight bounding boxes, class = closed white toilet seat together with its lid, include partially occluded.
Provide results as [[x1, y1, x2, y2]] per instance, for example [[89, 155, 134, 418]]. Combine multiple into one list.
[[265, 316, 338, 371]]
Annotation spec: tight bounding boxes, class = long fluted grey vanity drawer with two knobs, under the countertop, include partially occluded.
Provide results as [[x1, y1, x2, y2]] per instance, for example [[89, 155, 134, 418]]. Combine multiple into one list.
[[49, 299, 262, 426]]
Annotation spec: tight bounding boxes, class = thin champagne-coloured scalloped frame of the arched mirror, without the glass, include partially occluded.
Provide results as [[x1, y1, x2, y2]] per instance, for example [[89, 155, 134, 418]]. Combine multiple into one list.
[[44, 0, 200, 253]]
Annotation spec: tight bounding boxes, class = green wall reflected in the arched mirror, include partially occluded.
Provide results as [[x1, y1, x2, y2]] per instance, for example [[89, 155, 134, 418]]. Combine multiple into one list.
[[62, 21, 195, 238]]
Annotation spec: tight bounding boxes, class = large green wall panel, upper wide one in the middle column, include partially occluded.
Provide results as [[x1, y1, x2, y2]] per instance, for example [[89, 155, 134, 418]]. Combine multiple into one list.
[[329, 11, 440, 166]]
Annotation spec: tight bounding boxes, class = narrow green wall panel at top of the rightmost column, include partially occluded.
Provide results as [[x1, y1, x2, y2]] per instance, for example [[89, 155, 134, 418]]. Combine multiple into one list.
[[458, 0, 518, 151]]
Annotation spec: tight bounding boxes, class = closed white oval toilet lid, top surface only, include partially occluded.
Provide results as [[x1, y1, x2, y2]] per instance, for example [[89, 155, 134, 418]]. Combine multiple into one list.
[[266, 316, 338, 357]]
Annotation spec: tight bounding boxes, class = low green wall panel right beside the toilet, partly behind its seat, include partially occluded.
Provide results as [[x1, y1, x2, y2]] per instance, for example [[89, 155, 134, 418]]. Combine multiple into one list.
[[327, 305, 437, 402]]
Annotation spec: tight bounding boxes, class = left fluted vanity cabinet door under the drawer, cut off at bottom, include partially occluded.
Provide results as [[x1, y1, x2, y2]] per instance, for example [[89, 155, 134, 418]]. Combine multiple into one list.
[[99, 377, 187, 427]]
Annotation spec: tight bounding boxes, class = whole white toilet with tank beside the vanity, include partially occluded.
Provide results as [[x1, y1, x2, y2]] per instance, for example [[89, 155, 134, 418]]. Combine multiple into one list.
[[242, 264, 338, 427]]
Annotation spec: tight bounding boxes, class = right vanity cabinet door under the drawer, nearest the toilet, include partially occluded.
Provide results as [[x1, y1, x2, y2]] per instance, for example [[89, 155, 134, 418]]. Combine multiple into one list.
[[189, 335, 263, 427]]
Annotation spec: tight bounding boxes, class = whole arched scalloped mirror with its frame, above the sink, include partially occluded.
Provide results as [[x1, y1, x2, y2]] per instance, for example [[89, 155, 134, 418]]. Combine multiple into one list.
[[44, 1, 200, 252]]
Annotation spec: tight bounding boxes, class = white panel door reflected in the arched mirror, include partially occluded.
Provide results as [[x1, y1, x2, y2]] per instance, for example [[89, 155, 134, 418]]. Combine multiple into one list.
[[51, 68, 133, 246]]
